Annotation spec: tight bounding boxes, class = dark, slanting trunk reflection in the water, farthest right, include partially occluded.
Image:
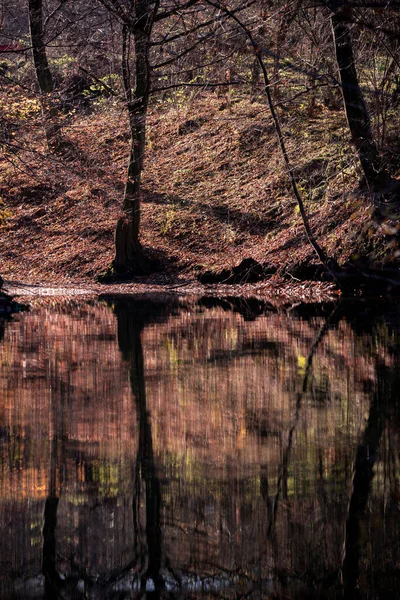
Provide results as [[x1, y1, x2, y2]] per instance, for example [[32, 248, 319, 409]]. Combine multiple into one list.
[[342, 368, 391, 598]]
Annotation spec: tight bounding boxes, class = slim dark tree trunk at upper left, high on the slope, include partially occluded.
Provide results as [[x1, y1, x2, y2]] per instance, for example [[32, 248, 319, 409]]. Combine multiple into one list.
[[28, 0, 60, 150]]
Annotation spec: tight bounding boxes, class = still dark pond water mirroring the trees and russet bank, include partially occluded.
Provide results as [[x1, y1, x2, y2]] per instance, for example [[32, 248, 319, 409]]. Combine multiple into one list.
[[0, 300, 400, 599]]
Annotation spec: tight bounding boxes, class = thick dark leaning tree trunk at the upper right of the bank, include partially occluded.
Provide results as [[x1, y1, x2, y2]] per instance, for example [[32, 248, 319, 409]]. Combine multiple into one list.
[[329, 0, 394, 195]]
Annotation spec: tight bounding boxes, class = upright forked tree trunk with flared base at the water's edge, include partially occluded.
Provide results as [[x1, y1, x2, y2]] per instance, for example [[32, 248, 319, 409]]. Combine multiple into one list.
[[114, 5, 152, 273]]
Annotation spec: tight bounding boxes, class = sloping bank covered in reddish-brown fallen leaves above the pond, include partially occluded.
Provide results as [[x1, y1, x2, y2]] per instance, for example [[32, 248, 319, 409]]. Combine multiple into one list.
[[0, 92, 398, 301]]
